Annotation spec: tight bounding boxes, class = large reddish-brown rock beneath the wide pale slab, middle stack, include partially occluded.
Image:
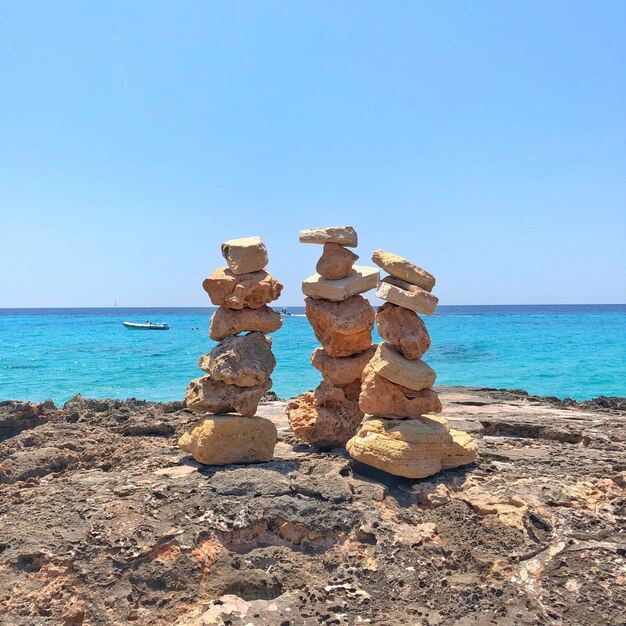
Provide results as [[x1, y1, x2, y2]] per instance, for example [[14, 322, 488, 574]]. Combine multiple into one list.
[[304, 296, 374, 357]]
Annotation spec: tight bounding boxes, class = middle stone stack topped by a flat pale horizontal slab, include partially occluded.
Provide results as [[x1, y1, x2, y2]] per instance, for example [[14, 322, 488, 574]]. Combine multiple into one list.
[[286, 226, 379, 447]]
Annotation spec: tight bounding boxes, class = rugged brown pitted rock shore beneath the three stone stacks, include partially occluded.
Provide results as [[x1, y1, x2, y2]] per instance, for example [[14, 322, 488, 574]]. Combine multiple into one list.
[[0, 388, 626, 626]]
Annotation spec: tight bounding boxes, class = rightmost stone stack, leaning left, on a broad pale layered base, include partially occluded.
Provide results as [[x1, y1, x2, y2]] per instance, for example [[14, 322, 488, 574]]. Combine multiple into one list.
[[346, 250, 477, 478]]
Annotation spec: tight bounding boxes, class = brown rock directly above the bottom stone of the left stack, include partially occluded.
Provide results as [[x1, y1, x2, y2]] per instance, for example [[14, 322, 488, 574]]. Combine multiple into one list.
[[185, 376, 272, 417]]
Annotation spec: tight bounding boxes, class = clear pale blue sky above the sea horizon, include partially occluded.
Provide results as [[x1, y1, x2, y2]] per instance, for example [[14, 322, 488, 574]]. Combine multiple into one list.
[[0, 0, 626, 307]]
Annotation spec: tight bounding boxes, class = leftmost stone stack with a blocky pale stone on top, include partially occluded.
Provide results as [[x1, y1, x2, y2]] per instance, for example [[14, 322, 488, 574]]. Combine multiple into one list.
[[178, 237, 283, 465]]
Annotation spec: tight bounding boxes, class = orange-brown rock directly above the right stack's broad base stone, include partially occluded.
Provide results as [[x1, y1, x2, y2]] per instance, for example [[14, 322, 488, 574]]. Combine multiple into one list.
[[359, 364, 442, 418]]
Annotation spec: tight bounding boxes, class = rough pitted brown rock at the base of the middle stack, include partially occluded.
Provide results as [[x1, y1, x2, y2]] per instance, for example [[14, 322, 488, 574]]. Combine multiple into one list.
[[285, 382, 363, 448]]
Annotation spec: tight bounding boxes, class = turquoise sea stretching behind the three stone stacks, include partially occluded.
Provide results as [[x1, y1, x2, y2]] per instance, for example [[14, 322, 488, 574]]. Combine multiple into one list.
[[0, 305, 626, 403]]
